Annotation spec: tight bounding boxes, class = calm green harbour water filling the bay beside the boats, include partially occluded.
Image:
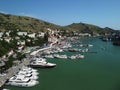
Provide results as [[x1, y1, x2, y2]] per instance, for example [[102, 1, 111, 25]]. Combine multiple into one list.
[[6, 38, 120, 90]]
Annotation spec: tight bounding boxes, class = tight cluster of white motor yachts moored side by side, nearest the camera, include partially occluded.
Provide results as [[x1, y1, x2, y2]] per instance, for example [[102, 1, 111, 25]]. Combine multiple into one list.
[[6, 67, 39, 87]]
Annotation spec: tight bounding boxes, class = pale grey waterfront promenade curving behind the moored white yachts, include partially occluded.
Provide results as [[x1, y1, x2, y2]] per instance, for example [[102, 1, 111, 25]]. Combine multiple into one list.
[[0, 42, 56, 90]]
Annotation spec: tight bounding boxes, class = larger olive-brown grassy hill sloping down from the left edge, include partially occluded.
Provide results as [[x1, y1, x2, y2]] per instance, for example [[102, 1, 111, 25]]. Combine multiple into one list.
[[0, 13, 60, 31]]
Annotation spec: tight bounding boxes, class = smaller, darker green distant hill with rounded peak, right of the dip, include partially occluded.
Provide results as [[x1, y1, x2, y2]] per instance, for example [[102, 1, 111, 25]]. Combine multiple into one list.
[[66, 23, 114, 34]]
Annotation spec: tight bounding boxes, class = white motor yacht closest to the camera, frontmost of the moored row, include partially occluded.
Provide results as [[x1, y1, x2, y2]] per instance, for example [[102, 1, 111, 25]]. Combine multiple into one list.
[[6, 75, 39, 87]]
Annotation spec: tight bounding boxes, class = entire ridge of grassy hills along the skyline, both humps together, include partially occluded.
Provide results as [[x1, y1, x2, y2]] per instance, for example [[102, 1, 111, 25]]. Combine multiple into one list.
[[0, 13, 116, 34]]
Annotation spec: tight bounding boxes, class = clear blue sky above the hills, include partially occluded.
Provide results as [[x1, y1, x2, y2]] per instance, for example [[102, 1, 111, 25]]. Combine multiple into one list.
[[0, 0, 120, 30]]
